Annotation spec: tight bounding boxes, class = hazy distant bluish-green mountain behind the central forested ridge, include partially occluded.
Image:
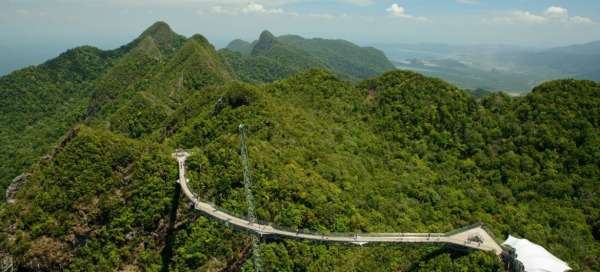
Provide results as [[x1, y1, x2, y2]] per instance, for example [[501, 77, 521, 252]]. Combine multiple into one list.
[[221, 31, 394, 83]]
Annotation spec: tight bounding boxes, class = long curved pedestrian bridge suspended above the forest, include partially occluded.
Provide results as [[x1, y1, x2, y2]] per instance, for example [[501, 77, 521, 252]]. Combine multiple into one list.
[[173, 151, 503, 255]]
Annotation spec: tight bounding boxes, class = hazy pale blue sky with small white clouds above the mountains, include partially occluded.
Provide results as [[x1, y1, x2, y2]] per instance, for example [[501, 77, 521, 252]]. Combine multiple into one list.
[[0, 0, 600, 72]]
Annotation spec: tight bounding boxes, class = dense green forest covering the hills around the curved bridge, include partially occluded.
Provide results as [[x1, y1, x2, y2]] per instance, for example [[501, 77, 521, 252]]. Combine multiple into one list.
[[0, 20, 600, 271]]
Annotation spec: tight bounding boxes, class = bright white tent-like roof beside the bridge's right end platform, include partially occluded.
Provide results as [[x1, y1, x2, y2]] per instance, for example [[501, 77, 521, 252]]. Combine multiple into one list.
[[502, 235, 571, 272]]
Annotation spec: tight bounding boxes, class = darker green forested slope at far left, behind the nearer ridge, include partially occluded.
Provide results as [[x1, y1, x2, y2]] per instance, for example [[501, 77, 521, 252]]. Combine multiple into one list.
[[0, 46, 119, 200]]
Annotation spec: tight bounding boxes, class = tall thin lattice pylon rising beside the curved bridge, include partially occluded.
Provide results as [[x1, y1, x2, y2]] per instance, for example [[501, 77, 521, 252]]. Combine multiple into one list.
[[238, 124, 262, 271]]
